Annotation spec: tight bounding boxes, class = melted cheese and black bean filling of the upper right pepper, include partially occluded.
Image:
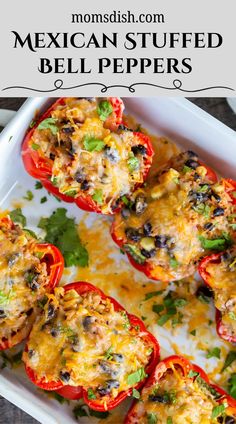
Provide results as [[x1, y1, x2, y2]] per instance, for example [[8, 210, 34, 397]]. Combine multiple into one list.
[[115, 152, 233, 281]]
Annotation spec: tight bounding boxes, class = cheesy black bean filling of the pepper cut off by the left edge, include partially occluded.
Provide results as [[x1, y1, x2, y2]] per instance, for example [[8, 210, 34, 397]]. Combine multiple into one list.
[[0, 219, 48, 344]]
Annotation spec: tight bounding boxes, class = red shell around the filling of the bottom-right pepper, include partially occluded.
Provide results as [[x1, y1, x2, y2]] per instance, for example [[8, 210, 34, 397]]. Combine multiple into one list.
[[124, 355, 236, 424]]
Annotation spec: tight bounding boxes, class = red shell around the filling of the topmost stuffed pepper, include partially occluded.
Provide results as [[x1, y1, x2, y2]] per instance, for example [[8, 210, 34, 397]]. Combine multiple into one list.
[[22, 97, 154, 213]]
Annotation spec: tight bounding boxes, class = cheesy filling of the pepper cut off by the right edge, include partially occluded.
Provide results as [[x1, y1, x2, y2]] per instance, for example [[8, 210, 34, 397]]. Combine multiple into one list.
[[206, 248, 236, 336]]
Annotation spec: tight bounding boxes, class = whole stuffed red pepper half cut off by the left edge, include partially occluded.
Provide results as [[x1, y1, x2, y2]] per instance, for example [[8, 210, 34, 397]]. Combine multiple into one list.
[[0, 215, 64, 350]]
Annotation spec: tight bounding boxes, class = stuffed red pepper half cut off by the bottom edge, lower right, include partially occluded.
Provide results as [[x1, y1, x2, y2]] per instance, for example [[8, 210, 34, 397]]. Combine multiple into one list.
[[125, 356, 236, 424]]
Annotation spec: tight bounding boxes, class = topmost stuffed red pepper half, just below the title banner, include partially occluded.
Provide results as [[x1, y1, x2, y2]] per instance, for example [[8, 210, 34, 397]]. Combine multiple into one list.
[[22, 97, 153, 214]]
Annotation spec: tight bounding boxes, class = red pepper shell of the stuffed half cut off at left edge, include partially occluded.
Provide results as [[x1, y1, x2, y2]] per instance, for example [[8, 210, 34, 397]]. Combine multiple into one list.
[[0, 217, 64, 350]]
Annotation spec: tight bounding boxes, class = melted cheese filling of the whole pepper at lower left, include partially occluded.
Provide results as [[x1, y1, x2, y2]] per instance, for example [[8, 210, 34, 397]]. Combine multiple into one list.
[[23, 288, 152, 403]]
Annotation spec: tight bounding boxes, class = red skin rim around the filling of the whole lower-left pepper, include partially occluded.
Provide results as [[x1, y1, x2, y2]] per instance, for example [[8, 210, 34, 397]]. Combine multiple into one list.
[[26, 281, 160, 411]]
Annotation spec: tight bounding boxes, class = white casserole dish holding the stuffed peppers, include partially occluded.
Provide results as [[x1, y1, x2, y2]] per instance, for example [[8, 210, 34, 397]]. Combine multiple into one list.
[[0, 97, 236, 424]]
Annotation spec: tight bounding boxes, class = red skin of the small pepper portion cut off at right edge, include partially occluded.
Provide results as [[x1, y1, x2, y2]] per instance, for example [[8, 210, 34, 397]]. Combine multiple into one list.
[[198, 252, 236, 343]]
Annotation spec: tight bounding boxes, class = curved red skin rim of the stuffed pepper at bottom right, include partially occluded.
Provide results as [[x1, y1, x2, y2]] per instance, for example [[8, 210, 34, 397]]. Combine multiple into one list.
[[124, 355, 236, 424]]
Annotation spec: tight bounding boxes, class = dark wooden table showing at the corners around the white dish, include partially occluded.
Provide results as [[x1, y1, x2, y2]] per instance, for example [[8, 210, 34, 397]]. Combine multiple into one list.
[[0, 97, 236, 424]]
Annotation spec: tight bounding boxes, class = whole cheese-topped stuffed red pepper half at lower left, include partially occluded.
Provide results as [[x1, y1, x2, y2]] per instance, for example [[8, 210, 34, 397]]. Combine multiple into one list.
[[23, 282, 159, 411]]
